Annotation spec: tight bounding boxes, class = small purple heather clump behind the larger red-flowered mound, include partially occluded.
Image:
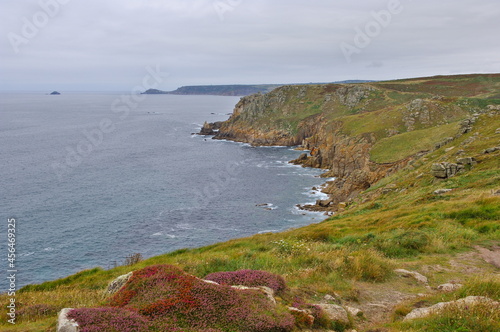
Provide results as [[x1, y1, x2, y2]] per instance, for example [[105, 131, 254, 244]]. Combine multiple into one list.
[[205, 270, 286, 293]]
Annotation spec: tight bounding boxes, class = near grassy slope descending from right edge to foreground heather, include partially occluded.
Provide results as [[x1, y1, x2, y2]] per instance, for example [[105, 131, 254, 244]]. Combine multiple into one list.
[[0, 75, 500, 331]]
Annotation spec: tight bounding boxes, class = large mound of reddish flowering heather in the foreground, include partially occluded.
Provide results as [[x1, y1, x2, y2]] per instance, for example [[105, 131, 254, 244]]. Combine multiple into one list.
[[105, 265, 295, 332]]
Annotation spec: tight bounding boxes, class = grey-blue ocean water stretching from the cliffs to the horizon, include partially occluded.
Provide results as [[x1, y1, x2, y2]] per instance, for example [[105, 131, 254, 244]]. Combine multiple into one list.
[[0, 93, 324, 292]]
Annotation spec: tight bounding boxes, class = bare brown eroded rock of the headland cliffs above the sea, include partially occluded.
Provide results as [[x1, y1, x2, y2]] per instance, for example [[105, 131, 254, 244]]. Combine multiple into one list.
[[215, 89, 408, 211]]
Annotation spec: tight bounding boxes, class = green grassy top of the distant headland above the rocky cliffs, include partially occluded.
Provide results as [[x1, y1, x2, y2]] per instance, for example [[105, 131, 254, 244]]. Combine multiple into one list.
[[230, 74, 500, 163]]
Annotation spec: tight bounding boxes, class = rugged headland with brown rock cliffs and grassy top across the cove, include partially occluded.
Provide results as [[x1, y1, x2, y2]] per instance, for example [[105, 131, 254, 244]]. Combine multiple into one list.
[[210, 75, 500, 210]]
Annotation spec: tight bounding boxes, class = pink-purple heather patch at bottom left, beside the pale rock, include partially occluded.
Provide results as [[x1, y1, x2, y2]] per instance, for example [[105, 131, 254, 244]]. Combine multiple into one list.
[[67, 308, 149, 332]]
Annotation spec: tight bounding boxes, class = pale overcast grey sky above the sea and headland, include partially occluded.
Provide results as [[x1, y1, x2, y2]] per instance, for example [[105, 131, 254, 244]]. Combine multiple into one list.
[[0, 0, 500, 91]]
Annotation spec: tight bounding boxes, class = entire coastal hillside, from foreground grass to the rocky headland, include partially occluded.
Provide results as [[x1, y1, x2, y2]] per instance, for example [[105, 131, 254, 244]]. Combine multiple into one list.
[[0, 74, 500, 332]]
